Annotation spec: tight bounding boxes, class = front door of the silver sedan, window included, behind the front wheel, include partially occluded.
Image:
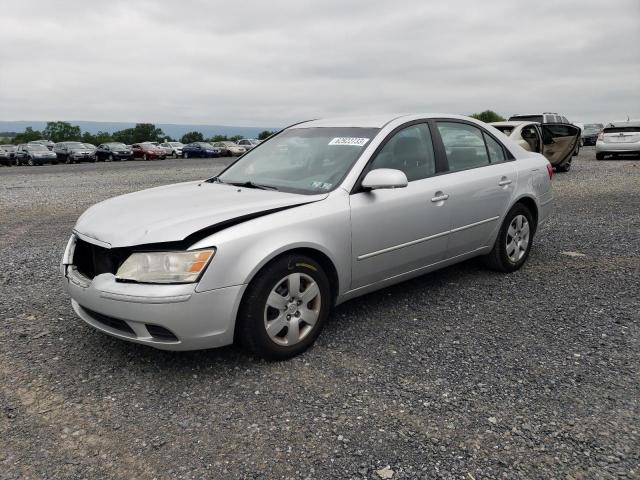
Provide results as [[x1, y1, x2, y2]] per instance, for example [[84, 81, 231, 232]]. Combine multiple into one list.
[[350, 123, 450, 289]]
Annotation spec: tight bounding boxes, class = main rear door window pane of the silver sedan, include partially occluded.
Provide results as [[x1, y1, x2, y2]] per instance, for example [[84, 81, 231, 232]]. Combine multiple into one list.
[[437, 122, 492, 172]]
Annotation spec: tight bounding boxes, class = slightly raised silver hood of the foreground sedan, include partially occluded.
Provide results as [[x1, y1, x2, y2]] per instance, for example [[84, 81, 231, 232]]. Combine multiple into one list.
[[74, 181, 328, 248]]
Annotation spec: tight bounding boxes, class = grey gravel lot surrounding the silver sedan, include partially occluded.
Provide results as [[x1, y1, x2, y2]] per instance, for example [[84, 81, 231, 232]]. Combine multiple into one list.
[[0, 147, 640, 480]]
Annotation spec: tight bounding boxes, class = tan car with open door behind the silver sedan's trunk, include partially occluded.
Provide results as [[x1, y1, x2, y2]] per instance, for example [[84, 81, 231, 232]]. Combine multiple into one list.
[[490, 121, 580, 172]]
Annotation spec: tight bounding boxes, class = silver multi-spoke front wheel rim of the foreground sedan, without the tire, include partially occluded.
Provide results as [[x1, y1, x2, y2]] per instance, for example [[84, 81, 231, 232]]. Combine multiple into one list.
[[264, 272, 322, 346]]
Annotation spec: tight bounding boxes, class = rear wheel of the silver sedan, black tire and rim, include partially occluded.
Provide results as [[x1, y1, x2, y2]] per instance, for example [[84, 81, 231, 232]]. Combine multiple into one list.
[[484, 203, 536, 273]]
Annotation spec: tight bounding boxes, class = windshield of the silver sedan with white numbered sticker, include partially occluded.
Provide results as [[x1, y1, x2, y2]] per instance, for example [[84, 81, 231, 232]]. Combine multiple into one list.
[[218, 127, 379, 194]]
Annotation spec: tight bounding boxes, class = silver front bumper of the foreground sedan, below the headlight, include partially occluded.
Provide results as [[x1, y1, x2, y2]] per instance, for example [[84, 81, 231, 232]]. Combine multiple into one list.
[[62, 264, 246, 350]]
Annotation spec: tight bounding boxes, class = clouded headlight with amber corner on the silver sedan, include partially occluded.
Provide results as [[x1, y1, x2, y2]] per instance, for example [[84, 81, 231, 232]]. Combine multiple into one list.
[[116, 249, 216, 283]]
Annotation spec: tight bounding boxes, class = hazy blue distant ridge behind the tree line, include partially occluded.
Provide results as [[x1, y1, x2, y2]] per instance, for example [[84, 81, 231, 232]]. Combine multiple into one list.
[[0, 120, 279, 138]]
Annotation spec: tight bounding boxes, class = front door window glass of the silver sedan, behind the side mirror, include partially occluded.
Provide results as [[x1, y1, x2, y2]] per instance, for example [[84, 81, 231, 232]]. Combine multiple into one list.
[[371, 123, 436, 182]]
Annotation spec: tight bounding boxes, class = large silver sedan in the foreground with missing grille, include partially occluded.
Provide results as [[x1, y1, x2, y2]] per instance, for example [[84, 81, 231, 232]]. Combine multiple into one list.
[[61, 115, 553, 359]]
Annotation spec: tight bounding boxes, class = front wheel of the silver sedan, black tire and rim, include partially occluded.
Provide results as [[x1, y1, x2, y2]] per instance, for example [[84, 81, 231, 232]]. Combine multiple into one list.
[[235, 254, 333, 360]]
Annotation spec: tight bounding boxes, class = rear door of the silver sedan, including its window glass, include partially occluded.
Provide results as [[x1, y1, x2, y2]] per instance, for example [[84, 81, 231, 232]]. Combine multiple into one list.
[[437, 119, 517, 258]]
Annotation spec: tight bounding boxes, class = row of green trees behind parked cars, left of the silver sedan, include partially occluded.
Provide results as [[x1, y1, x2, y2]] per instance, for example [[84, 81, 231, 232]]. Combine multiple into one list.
[[4, 122, 275, 145]]
